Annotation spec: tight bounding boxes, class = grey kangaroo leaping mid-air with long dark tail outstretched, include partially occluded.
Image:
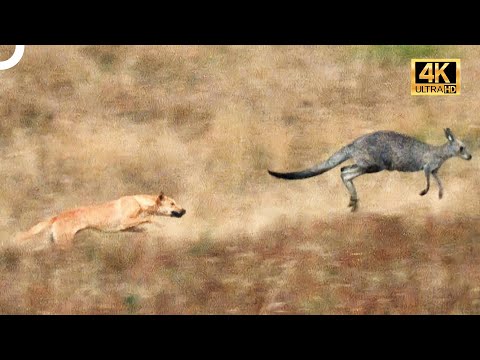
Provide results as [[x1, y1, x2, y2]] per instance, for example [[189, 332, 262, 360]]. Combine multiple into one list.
[[268, 128, 472, 211]]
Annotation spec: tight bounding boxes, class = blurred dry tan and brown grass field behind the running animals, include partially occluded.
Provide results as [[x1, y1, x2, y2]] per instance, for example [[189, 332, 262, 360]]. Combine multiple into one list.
[[0, 46, 480, 314]]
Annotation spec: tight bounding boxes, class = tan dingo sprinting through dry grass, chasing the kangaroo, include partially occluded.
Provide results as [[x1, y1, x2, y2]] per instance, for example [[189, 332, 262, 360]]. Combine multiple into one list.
[[17, 192, 186, 245]]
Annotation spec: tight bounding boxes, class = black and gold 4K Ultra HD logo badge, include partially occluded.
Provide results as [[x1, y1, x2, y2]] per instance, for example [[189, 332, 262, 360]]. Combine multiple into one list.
[[412, 59, 460, 95]]
